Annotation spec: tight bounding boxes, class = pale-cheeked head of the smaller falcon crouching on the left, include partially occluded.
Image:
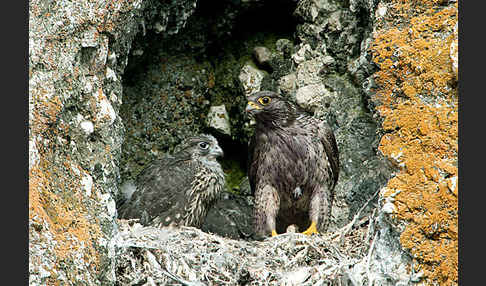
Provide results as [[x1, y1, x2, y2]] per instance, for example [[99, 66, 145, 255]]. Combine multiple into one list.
[[174, 134, 223, 162]]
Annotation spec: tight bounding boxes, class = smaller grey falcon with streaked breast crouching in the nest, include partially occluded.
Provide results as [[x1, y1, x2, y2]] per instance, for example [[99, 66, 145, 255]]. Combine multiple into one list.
[[119, 135, 225, 228]]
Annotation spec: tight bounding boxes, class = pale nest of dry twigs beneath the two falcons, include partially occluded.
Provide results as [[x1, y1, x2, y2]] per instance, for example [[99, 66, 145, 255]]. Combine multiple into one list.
[[117, 206, 373, 286]]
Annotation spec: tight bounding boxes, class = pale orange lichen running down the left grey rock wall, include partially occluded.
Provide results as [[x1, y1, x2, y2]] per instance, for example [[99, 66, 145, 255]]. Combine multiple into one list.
[[29, 94, 102, 280]]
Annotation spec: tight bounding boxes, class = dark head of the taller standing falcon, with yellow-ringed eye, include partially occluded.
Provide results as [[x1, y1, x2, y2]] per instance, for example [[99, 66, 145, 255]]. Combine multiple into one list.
[[245, 91, 295, 125]]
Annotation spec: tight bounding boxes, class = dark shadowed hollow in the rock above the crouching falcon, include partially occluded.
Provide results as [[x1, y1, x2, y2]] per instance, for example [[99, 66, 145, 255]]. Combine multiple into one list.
[[120, 0, 297, 193]]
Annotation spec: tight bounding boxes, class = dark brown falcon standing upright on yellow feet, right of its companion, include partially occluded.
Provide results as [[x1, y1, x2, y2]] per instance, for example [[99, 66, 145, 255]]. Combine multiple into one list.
[[246, 91, 339, 237]]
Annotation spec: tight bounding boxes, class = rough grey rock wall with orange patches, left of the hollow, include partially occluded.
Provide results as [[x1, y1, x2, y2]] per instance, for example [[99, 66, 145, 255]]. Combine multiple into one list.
[[29, 0, 200, 285]]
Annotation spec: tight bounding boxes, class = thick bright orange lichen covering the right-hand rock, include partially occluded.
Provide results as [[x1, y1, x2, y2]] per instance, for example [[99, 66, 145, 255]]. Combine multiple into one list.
[[371, 0, 458, 285]]
